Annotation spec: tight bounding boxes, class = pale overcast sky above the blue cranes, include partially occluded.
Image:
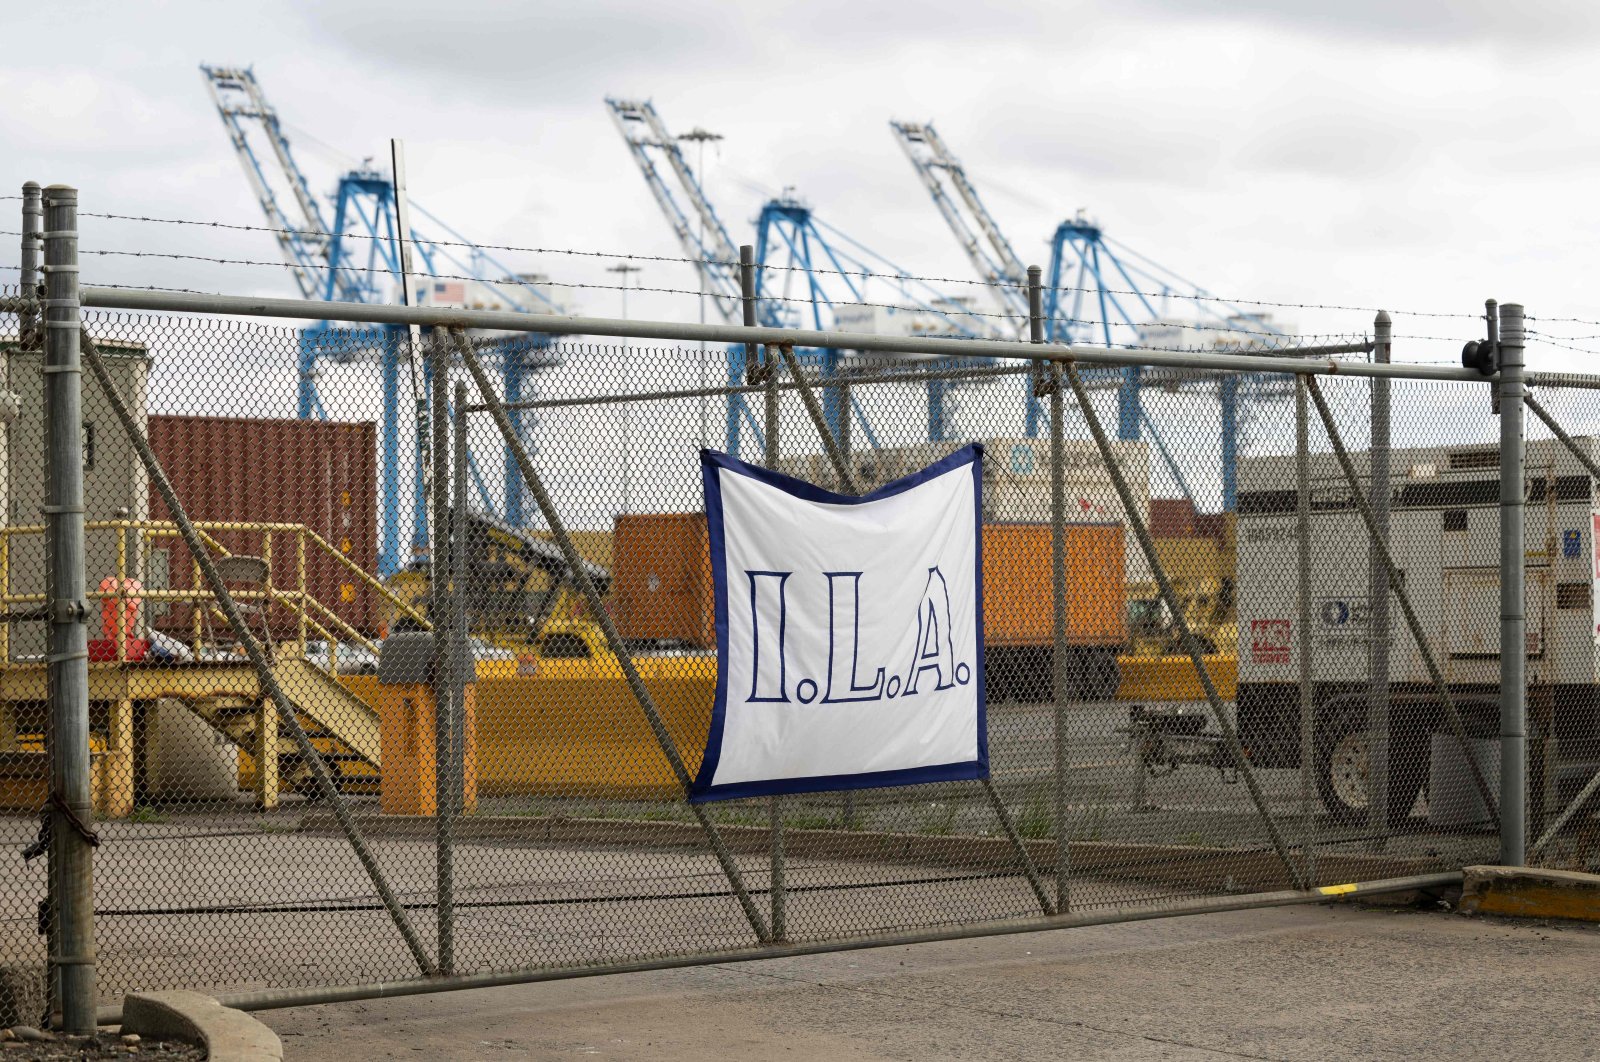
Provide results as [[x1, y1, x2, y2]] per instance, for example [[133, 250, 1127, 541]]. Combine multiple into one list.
[[0, 0, 1600, 521]]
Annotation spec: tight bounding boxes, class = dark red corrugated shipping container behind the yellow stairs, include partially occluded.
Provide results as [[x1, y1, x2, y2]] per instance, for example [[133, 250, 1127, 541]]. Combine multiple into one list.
[[149, 416, 381, 637]]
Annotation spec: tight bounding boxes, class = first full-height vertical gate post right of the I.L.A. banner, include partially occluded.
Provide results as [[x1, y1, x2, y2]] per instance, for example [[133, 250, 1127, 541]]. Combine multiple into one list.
[[1027, 266, 1072, 915]]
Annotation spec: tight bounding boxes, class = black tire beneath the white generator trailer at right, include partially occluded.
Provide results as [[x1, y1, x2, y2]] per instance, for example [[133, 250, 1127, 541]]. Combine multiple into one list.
[[1315, 704, 1427, 825]]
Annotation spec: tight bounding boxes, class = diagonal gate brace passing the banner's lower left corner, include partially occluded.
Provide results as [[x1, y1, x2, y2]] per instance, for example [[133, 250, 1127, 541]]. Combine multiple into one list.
[[450, 328, 771, 944]]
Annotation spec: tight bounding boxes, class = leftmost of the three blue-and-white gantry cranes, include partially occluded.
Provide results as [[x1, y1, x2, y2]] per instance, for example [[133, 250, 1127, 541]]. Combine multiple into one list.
[[200, 66, 566, 576]]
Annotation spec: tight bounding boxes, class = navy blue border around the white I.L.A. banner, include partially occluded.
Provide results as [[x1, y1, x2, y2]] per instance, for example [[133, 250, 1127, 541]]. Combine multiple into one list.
[[690, 443, 989, 803]]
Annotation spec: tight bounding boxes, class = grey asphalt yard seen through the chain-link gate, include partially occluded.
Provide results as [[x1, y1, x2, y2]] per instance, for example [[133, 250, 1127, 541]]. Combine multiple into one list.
[[0, 704, 1496, 1004]]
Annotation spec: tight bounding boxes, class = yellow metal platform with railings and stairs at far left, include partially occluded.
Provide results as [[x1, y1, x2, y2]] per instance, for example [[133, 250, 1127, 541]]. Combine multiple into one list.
[[0, 520, 427, 816]]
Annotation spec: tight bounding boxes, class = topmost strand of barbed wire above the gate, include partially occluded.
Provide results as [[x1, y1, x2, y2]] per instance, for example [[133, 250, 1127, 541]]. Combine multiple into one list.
[[50, 211, 1491, 323]]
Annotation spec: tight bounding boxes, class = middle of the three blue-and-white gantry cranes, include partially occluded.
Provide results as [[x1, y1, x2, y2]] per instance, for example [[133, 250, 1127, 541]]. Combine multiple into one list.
[[606, 98, 997, 453]]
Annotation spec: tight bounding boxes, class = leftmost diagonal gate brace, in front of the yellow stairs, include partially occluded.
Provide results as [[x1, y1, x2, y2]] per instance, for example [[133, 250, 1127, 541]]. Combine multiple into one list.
[[83, 329, 435, 977]]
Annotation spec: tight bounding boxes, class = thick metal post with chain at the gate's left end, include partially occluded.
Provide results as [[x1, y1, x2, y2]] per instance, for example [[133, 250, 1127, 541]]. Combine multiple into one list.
[[43, 184, 99, 1036]]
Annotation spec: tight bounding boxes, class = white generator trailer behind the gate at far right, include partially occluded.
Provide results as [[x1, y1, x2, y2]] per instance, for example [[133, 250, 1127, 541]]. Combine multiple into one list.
[[1237, 438, 1600, 820]]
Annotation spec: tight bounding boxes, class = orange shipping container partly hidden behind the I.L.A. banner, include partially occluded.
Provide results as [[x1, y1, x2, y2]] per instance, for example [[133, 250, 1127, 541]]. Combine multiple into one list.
[[611, 512, 1128, 648]]
